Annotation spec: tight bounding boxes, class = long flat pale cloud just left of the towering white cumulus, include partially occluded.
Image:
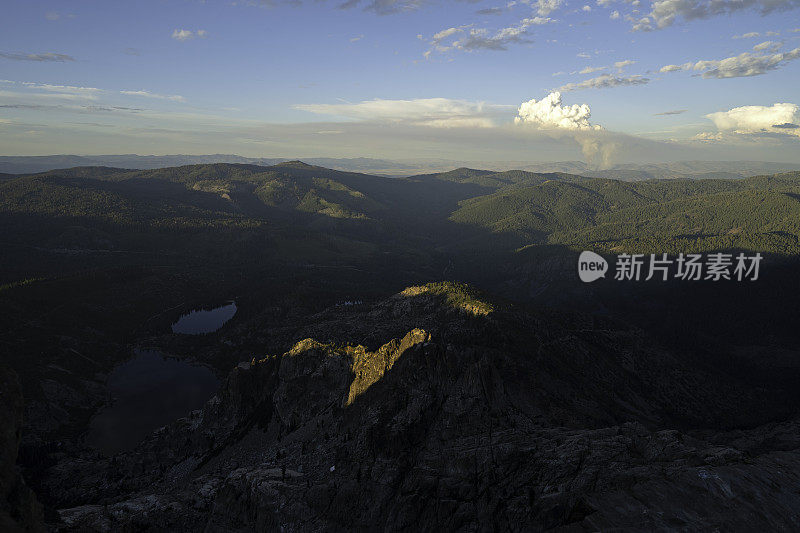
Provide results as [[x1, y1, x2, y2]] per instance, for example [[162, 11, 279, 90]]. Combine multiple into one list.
[[294, 98, 511, 128]]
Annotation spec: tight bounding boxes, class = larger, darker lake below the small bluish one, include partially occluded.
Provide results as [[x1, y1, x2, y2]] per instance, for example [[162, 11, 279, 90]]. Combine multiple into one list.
[[87, 350, 219, 455]]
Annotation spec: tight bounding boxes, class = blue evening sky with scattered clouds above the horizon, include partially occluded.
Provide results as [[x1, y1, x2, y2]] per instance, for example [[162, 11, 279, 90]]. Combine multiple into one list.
[[0, 0, 800, 167]]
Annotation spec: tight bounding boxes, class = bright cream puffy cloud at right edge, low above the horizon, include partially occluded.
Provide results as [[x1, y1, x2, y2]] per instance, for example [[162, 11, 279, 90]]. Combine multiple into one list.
[[706, 103, 800, 137]]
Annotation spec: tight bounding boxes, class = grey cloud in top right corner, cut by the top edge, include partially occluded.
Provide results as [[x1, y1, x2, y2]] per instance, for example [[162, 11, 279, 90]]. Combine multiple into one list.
[[633, 0, 800, 31]]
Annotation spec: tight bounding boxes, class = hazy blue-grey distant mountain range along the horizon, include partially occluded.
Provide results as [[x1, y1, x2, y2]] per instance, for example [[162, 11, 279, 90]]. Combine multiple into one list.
[[0, 154, 800, 181]]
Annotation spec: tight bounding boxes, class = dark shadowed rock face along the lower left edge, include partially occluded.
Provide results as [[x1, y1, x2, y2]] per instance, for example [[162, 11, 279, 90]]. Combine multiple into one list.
[[0, 366, 44, 531]]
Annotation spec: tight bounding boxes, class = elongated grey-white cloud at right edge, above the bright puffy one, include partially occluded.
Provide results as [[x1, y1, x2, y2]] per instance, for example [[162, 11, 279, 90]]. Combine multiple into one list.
[[659, 45, 800, 79]]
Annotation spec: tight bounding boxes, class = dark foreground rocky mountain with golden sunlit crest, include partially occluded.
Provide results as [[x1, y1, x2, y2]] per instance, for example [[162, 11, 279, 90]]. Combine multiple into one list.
[[46, 284, 800, 531]]
